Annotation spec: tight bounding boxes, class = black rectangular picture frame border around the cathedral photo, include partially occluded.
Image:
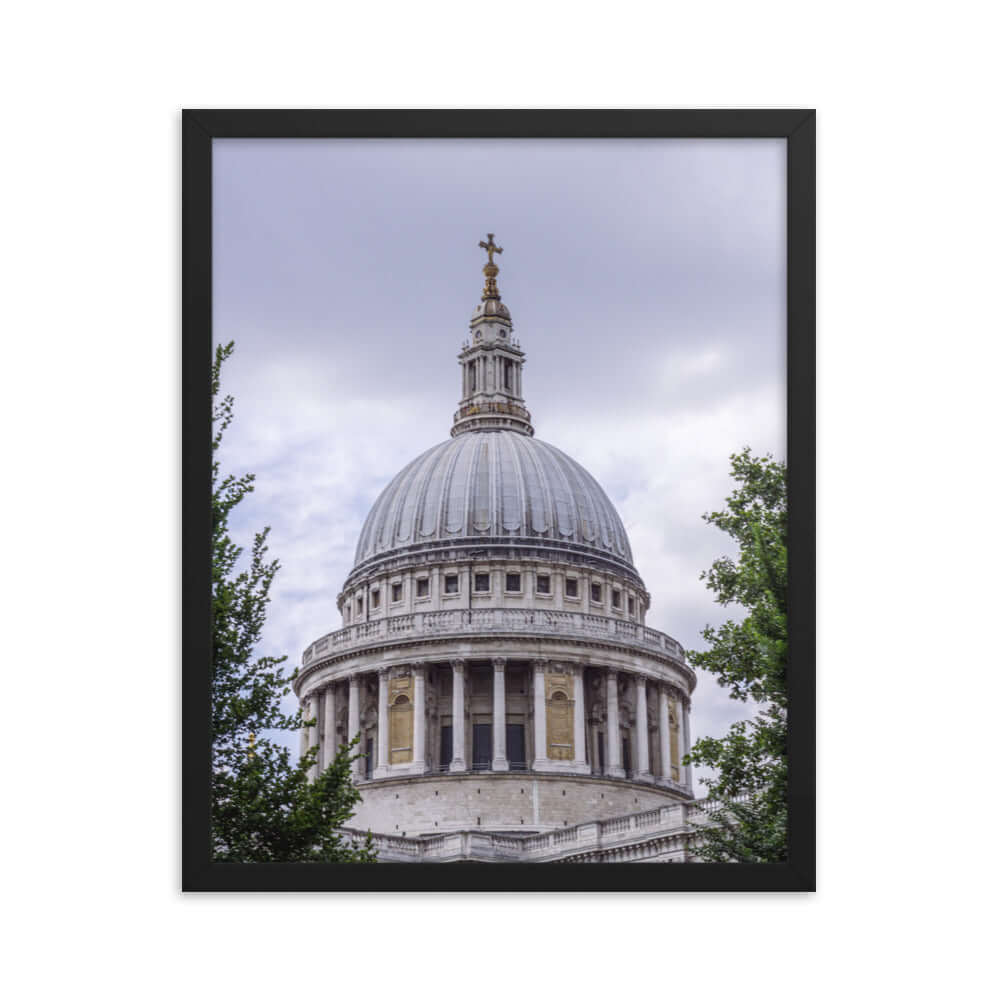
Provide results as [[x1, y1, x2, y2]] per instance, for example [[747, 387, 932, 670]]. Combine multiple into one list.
[[181, 110, 816, 892]]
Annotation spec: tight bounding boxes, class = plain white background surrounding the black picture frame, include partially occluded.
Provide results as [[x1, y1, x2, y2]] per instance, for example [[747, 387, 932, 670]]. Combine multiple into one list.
[[0, 2, 1000, 997]]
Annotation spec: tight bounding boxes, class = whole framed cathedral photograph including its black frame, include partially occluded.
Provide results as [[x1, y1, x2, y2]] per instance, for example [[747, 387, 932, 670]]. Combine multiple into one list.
[[182, 110, 816, 891]]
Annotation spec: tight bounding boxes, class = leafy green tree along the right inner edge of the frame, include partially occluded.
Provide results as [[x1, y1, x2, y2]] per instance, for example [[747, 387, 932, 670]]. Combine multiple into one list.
[[686, 448, 788, 862]]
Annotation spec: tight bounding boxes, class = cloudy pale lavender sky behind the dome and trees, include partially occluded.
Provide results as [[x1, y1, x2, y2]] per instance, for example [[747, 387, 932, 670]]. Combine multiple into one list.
[[213, 139, 785, 788]]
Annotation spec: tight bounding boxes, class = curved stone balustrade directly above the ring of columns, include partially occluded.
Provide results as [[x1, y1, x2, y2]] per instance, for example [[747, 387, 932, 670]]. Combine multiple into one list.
[[302, 608, 684, 667]]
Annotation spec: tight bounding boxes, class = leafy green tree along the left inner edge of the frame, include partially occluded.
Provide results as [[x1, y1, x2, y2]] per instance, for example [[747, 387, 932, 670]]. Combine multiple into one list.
[[211, 343, 375, 862]]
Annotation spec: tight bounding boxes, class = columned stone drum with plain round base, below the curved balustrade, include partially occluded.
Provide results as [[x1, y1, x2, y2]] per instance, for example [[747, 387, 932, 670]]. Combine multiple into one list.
[[297, 642, 691, 835]]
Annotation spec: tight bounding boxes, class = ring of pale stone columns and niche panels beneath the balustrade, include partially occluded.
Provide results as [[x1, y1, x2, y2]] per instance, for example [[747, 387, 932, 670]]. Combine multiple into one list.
[[301, 657, 691, 788]]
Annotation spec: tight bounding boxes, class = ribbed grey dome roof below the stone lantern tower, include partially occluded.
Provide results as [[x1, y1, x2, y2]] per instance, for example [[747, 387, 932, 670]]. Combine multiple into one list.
[[354, 430, 632, 567]]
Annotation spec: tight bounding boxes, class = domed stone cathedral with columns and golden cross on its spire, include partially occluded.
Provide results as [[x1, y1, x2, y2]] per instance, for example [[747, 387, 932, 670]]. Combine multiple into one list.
[[295, 236, 695, 860]]
